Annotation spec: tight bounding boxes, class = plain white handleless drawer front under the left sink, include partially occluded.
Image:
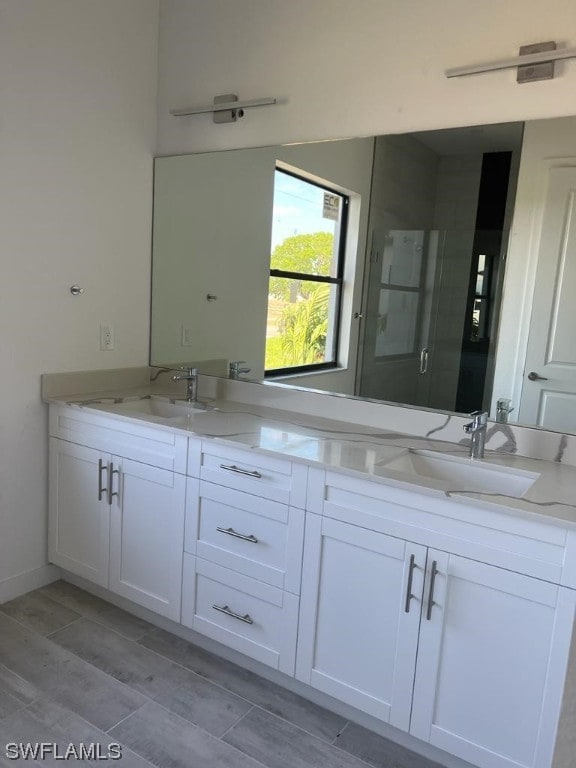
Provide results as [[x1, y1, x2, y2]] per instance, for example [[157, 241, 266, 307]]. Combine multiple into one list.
[[50, 405, 188, 474]]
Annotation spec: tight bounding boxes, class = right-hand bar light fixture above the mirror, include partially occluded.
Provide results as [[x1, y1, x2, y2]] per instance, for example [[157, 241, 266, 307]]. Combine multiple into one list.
[[445, 41, 576, 83]]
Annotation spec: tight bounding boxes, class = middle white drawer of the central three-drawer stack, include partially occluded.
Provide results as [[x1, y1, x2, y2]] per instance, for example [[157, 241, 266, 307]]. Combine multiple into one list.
[[185, 478, 304, 593]]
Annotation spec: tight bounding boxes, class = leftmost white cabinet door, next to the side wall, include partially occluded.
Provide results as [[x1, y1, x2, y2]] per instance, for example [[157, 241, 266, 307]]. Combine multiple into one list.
[[48, 438, 110, 587]]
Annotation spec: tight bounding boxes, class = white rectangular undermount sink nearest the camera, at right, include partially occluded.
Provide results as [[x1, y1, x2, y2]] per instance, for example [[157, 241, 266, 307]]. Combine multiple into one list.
[[381, 451, 540, 499]]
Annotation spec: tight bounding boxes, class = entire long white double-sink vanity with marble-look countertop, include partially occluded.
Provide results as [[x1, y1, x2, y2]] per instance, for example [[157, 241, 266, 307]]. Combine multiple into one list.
[[49, 395, 576, 768]]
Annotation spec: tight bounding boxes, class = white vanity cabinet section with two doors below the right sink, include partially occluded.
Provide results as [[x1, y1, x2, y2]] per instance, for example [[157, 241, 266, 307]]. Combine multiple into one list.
[[296, 471, 576, 768]]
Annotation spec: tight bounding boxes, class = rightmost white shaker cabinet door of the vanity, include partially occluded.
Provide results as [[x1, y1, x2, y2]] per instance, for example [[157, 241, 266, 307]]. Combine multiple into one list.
[[410, 550, 575, 768]]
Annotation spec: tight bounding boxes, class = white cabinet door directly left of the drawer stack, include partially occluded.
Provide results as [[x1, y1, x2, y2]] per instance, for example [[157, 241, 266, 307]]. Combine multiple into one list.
[[110, 457, 186, 621]]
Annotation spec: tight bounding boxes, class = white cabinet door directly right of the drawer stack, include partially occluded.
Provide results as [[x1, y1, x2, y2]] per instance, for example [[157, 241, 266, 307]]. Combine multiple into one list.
[[296, 514, 426, 730]]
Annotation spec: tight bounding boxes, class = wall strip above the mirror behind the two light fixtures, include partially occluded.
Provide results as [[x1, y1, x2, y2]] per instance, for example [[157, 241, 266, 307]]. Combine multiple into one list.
[[158, 0, 576, 154]]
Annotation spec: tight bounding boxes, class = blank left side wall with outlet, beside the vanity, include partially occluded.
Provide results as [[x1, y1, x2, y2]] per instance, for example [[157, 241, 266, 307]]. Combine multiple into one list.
[[0, 0, 158, 601]]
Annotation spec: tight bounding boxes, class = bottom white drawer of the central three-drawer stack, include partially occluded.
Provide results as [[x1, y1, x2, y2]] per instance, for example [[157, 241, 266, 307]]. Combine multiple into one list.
[[182, 553, 298, 675]]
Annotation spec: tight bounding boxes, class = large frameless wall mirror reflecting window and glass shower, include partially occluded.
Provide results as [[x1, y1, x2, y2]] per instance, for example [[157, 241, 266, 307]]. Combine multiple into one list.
[[151, 118, 576, 433]]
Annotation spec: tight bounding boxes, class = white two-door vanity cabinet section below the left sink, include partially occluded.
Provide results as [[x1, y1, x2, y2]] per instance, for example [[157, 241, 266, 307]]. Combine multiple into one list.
[[49, 406, 187, 621]]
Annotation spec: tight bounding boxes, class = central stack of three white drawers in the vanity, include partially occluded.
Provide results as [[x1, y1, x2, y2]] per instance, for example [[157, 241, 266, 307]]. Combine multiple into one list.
[[182, 441, 307, 675]]
